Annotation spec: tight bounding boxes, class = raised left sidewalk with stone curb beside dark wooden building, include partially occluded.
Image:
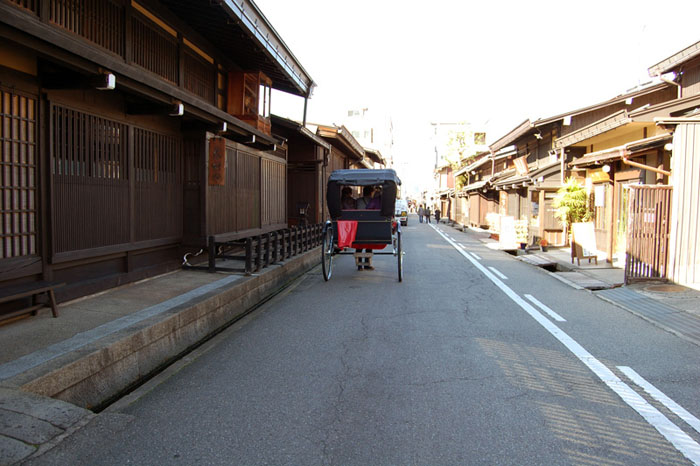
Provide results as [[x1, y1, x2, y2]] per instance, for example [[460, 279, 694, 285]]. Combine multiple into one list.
[[0, 249, 319, 466]]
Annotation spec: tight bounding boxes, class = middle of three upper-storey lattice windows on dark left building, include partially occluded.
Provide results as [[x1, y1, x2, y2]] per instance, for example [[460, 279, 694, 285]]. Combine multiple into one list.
[[131, 15, 178, 84]]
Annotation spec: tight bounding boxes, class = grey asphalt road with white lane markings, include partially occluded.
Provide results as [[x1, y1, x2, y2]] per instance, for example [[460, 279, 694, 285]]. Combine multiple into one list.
[[30, 216, 700, 465]]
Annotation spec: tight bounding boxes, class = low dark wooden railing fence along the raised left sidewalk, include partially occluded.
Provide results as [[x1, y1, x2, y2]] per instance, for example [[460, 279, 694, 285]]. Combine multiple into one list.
[[182, 223, 323, 274]]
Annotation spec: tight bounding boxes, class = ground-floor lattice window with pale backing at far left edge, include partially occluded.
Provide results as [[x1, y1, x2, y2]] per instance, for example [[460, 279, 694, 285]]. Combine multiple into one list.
[[0, 88, 37, 258]]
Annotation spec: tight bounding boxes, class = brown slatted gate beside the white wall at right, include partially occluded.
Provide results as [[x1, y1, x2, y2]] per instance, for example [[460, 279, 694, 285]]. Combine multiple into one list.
[[625, 186, 673, 284]]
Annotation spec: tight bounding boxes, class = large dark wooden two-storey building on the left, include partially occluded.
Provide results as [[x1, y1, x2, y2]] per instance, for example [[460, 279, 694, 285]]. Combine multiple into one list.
[[0, 0, 313, 304]]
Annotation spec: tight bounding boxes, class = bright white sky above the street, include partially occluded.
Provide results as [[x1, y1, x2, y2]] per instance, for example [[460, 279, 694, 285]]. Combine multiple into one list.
[[255, 0, 700, 191]]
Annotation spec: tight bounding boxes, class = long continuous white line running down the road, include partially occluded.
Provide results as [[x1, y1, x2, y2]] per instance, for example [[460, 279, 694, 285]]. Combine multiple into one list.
[[431, 225, 700, 465]]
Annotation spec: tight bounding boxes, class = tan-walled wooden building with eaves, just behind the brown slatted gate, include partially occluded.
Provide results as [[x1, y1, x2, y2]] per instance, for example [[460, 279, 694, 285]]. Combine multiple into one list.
[[555, 83, 678, 264]]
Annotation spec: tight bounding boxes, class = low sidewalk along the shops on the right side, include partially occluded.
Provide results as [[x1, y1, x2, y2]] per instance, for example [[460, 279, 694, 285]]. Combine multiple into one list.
[[442, 220, 700, 346]]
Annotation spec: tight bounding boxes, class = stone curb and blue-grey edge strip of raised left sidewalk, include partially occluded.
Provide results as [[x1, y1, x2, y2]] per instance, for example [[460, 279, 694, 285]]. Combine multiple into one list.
[[0, 248, 319, 409]]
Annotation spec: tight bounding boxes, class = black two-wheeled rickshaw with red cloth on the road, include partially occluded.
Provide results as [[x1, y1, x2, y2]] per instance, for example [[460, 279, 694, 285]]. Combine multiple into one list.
[[321, 169, 403, 281]]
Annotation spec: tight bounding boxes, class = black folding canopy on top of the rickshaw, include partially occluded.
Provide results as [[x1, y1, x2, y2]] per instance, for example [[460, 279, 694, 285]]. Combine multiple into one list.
[[326, 168, 401, 219]]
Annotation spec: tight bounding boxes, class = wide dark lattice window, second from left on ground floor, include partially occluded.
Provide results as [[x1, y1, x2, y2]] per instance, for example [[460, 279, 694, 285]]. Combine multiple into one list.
[[51, 106, 129, 253]]
